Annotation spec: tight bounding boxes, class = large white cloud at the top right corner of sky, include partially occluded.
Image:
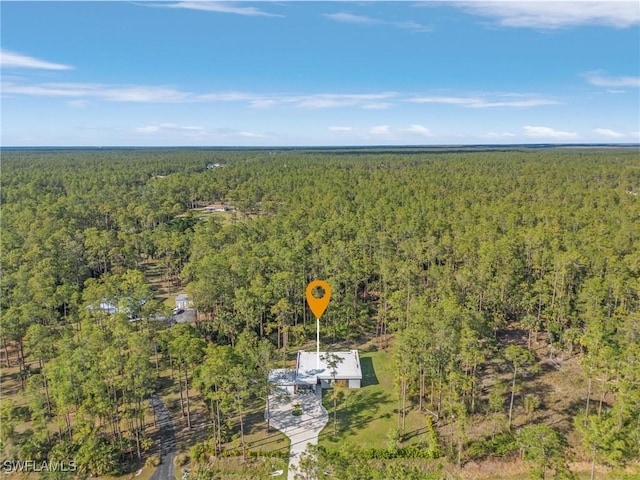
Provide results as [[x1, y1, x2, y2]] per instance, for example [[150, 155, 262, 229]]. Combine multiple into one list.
[[452, 0, 640, 29]]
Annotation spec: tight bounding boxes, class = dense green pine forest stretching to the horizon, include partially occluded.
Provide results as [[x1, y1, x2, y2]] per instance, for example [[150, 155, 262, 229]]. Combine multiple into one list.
[[0, 148, 640, 479]]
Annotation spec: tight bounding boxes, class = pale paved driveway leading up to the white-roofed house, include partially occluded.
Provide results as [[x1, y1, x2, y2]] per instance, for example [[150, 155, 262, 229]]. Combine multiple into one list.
[[265, 389, 329, 480]]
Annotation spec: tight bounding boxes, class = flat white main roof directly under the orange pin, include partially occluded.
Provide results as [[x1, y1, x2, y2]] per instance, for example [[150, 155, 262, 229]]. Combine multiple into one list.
[[296, 350, 362, 385]]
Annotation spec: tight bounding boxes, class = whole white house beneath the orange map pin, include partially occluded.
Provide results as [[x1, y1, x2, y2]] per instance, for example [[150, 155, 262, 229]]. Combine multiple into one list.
[[269, 350, 362, 394]]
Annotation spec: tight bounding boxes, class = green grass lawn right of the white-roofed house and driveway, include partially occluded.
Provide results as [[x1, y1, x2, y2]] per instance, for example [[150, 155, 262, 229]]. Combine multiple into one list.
[[319, 351, 426, 448]]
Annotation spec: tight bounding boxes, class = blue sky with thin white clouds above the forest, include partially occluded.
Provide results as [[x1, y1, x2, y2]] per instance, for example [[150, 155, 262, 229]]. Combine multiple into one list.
[[0, 0, 640, 146]]
